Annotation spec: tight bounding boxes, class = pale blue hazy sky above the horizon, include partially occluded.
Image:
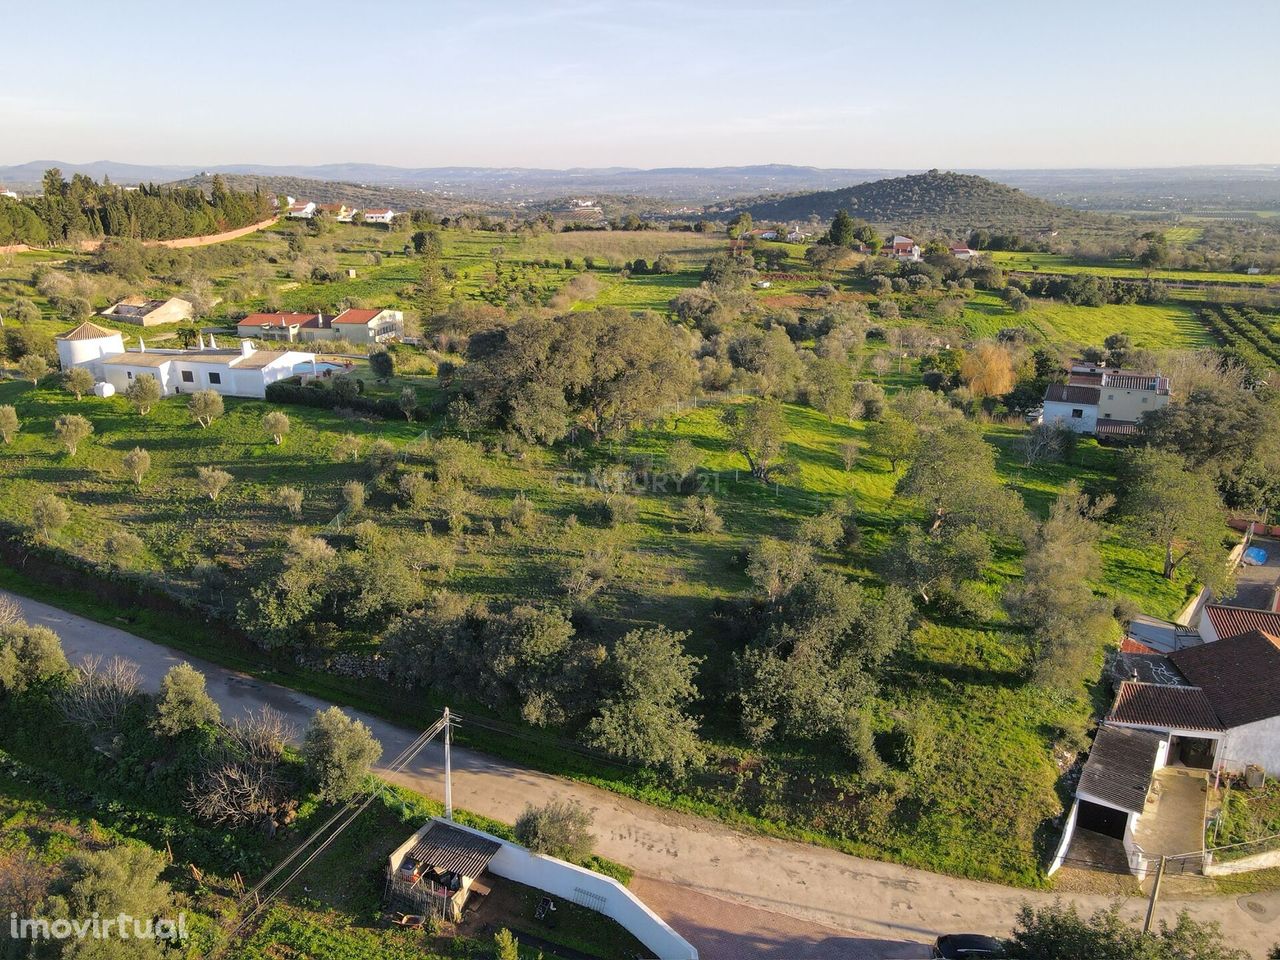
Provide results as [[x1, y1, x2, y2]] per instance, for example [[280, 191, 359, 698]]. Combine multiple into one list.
[[0, 0, 1280, 169]]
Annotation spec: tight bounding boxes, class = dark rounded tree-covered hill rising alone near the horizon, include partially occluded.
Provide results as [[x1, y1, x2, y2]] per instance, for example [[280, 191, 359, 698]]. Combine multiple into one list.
[[724, 170, 1089, 232]]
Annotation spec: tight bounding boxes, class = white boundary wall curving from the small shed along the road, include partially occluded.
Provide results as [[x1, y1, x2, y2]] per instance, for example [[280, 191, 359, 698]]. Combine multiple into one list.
[[430, 817, 698, 960]]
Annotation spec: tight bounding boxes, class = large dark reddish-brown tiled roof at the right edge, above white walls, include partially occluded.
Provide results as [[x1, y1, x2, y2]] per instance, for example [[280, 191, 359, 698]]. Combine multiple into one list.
[[1169, 630, 1280, 727]]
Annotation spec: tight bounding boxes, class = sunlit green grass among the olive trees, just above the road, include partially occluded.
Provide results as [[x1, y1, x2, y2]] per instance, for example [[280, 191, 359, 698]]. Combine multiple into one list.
[[0, 366, 1187, 883]]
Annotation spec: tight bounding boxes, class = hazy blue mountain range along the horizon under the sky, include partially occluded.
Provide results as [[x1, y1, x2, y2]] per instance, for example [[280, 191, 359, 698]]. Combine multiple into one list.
[[0, 160, 1280, 212]]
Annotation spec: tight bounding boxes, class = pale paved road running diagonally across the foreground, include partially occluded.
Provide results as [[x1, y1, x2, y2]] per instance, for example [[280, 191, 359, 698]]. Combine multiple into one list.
[[14, 596, 1280, 960]]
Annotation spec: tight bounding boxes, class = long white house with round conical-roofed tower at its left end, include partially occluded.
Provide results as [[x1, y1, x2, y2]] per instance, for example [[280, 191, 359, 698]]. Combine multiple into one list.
[[58, 323, 316, 397]]
